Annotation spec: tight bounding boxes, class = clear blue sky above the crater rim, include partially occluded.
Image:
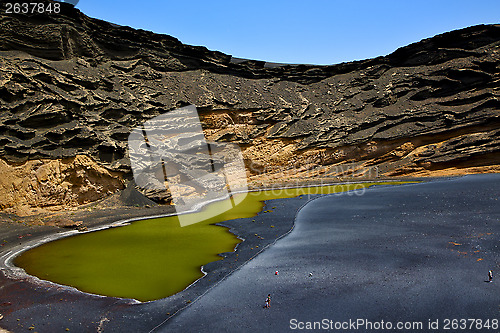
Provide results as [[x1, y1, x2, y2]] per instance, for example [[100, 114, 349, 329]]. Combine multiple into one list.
[[77, 0, 500, 64]]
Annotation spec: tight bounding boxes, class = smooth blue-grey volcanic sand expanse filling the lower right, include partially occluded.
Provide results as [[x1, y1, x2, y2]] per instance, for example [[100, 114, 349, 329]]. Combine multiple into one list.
[[159, 175, 500, 332]]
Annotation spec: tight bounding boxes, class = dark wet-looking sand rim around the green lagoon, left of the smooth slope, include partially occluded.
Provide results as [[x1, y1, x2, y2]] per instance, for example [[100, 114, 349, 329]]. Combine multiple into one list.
[[0, 182, 324, 332]]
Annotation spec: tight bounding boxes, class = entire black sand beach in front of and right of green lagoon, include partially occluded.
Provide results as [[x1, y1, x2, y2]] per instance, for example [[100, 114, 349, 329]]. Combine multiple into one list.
[[0, 174, 500, 332]]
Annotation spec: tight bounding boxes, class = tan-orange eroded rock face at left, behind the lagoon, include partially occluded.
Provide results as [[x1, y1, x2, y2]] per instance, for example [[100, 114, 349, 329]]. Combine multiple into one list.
[[0, 155, 124, 215]]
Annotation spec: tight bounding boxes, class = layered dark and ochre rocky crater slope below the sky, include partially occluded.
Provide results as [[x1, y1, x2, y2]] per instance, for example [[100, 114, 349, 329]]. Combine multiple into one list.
[[0, 4, 500, 212]]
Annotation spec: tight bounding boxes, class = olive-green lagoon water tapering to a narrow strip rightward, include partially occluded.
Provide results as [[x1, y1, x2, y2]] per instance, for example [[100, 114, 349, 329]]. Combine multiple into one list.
[[14, 182, 406, 301]]
